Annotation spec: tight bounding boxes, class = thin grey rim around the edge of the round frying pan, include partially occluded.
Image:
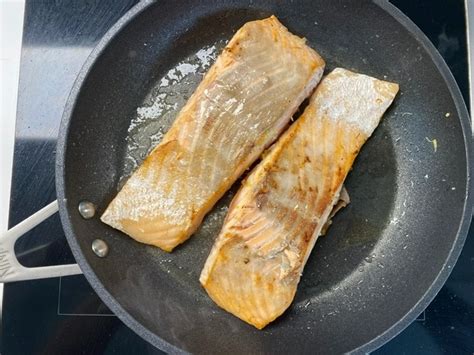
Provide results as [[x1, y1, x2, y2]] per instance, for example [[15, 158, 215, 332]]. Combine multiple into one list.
[[56, 0, 474, 353]]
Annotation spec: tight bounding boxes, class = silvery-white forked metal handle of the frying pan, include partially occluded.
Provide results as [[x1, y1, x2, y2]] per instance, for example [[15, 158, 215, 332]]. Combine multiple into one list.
[[0, 201, 82, 282]]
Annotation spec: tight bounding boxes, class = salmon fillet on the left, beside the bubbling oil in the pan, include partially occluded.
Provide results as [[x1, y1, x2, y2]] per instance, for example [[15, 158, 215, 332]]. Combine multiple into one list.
[[101, 16, 325, 251]]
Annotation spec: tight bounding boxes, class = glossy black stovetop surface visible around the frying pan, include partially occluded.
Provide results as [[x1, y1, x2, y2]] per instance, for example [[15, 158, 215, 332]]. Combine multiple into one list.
[[0, 0, 474, 354]]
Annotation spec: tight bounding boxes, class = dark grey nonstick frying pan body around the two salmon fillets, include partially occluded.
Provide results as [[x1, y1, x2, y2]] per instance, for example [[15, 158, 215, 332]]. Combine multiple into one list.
[[2, 0, 472, 353]]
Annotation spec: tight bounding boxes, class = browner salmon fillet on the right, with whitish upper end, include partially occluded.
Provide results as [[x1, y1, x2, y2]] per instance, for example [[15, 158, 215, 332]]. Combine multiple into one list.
[[200, 69, 398, 329]]
